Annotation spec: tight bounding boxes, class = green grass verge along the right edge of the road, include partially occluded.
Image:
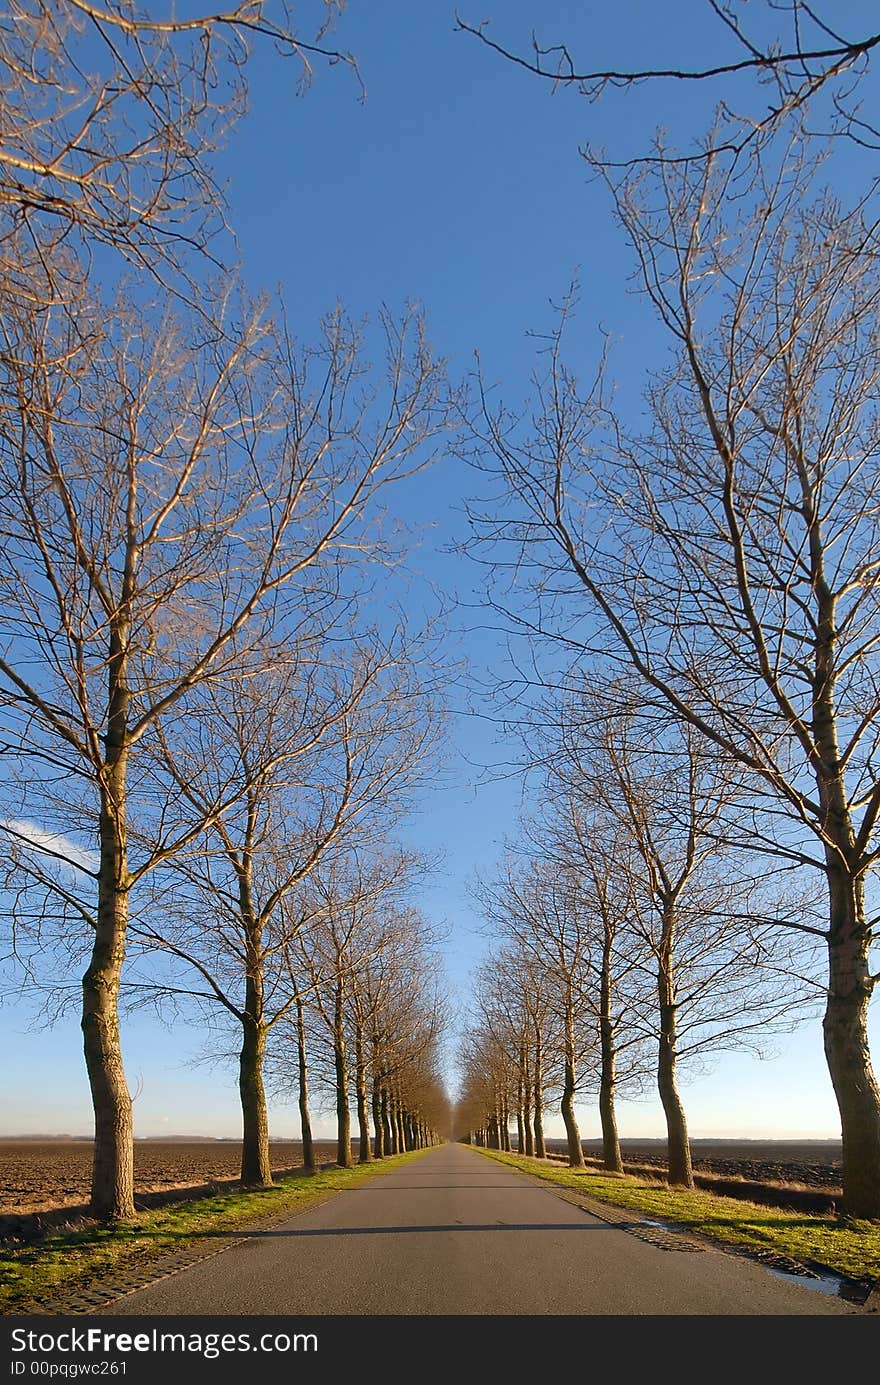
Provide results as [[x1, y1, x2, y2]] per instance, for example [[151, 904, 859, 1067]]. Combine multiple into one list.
[[478, 1150, 880, 1284]]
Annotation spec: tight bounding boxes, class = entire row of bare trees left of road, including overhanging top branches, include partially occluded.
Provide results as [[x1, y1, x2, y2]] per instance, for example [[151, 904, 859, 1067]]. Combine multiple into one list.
[[0, 0, 448, 1217]]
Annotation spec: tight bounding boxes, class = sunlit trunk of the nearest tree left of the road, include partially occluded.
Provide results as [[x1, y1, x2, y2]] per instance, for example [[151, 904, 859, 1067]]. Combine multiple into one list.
[[82, 753, 134, 1222]]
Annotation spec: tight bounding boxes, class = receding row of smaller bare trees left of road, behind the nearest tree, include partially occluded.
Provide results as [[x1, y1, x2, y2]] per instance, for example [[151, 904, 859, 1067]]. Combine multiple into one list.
[[142, 842, 446, 1187]]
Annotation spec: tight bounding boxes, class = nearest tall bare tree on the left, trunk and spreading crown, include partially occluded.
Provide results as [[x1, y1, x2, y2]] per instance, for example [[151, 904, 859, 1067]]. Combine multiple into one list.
[[0, 278, 451, 1217]]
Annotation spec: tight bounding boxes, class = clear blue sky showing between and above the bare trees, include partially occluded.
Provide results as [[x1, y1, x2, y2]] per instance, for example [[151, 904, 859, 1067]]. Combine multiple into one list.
[[0, 0, 880, 1137]]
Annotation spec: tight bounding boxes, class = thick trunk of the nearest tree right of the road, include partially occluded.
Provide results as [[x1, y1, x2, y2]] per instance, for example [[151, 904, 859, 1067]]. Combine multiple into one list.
[[822, 852, 880, 1220]]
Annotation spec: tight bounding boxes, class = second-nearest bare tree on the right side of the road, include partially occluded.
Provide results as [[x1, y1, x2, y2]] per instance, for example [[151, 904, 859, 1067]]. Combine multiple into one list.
[[565, 699, 802, 1187]]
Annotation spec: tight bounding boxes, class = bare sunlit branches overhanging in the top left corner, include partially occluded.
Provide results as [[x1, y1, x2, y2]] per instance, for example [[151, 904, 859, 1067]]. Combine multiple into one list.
[[0, 0, 353, 296]]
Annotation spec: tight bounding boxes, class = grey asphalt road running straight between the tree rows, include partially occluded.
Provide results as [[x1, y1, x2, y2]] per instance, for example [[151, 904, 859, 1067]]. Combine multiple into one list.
[[101, 1145, 859, 1316]]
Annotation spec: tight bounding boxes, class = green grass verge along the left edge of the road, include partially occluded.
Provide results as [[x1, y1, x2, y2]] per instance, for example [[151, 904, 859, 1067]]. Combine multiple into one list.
[[0, 1150, 425, 1313]]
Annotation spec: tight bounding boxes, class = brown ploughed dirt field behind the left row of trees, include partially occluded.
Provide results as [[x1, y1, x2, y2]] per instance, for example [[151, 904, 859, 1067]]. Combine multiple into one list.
[[0, 1140, 335, 1216]]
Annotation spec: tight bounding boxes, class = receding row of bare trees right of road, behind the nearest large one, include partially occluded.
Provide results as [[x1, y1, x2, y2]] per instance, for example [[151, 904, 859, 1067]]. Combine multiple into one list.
[[459, 683, 816, 1187]]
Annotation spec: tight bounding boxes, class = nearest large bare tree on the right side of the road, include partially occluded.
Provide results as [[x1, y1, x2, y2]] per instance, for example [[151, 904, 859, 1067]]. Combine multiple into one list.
[[471, 130, 880, 1217]]
